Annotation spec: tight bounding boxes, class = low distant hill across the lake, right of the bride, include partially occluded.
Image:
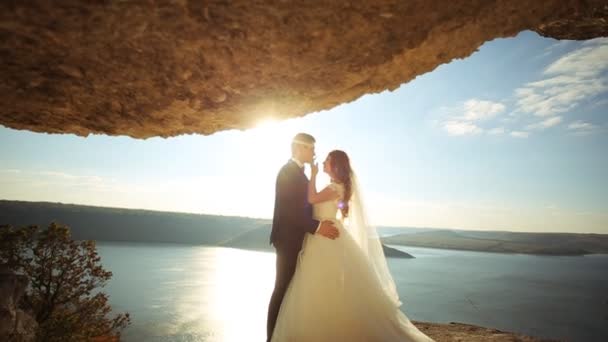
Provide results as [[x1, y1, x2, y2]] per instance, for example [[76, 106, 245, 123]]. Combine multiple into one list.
[[383, 229, 608, 255]]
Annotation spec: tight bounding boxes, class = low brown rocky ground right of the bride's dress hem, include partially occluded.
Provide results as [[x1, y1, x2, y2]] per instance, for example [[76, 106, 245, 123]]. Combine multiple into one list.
[[414, 322, 557, 342]]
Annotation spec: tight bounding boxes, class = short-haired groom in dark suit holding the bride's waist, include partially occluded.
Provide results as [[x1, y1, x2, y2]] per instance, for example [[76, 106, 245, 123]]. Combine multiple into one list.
[[267, 133, 339, 341]]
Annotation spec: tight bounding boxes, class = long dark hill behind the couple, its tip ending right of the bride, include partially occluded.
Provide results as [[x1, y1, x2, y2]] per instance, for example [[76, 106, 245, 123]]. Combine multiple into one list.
[[0, 200, 412, 258]]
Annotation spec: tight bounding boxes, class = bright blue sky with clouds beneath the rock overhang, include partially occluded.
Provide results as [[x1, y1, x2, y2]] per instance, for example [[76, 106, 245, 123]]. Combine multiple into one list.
[[0, 32, 608, 233]]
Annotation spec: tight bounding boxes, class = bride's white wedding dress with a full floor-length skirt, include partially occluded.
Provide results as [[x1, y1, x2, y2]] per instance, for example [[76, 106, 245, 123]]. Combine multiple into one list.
[[272, 183, 433, 342]]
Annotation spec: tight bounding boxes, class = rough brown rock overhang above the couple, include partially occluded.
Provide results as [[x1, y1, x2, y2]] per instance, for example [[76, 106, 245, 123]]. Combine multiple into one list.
[[0, 0, 608, 138]]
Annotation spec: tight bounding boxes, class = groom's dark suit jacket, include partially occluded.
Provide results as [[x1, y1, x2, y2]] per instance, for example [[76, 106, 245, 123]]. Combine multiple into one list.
[[270, 160, 319, 252]]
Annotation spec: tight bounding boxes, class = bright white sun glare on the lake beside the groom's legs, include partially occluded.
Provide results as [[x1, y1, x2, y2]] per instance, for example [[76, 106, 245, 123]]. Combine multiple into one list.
[[153, 247, 274, 342]]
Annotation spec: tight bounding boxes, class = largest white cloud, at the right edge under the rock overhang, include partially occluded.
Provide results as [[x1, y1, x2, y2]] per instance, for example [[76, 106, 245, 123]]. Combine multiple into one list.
[[515, 38, 608, 117]]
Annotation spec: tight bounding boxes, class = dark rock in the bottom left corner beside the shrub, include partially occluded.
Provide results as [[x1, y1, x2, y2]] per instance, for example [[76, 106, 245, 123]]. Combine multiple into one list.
[[0, 265, 38, 341]]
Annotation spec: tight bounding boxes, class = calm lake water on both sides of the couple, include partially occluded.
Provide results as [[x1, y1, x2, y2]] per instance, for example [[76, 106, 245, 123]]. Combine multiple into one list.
[[97, 242, 608, 342]]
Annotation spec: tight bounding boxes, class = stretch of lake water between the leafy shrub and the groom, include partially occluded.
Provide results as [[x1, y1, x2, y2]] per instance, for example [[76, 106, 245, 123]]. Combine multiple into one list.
[[98, 243, 275, 342]]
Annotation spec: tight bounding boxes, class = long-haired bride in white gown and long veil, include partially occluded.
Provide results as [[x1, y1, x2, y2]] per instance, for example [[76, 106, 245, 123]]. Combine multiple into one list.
[[272, 150, 433, 342]]
